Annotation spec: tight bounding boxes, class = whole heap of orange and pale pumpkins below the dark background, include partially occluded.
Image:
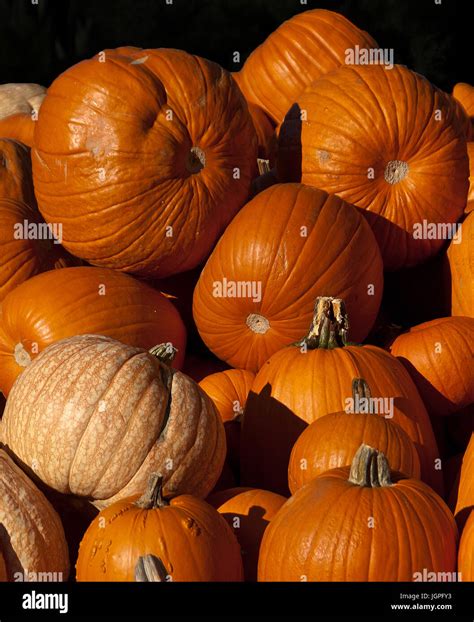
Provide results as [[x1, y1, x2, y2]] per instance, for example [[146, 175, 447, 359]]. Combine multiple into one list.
[[0, 10, 474, 581]]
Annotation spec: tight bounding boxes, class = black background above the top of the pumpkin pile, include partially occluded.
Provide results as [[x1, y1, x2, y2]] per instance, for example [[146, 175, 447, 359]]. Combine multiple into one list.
[[0, 0, 473, 91]]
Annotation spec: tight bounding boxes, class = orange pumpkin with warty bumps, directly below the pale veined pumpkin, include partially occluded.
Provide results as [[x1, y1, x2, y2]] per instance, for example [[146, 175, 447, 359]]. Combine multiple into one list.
[[76, 475, 242, 581]]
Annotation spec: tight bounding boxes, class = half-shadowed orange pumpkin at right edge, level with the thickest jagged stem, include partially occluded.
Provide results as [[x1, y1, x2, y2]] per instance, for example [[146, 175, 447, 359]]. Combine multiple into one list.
[[390, 317, 474, 415]]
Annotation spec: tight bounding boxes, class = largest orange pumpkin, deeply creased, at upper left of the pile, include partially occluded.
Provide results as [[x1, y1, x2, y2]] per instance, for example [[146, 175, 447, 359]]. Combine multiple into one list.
[[32, 48, 257, 278]]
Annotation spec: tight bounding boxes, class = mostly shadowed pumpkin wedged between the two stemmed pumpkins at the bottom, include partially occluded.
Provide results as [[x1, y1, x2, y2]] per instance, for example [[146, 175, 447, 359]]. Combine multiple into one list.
[[207, 488, 286, 581]]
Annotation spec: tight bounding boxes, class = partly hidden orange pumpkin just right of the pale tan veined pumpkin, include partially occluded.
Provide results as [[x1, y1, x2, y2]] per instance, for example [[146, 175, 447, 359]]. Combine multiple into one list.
[[199, 369, 255, 473]]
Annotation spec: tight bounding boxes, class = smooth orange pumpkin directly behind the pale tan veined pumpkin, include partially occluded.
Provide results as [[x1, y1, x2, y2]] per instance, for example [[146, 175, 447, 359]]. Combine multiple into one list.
[[0, 266, 186, 395]]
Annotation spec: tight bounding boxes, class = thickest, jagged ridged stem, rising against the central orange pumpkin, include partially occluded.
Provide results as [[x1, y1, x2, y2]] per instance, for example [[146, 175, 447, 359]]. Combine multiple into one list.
[[296, 296, 349, 350]]
